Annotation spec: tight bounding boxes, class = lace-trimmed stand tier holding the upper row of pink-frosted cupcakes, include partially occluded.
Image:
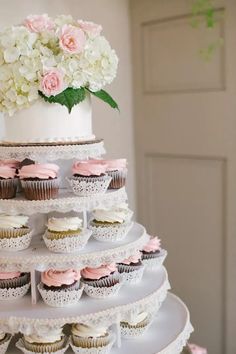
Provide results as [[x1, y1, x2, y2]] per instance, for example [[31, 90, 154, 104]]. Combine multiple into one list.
[[0, 187, 127, 215]]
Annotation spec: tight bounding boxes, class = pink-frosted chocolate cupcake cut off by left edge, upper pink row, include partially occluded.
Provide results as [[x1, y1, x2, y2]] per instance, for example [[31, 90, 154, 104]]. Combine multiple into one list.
[[0, 165, 18, 199]]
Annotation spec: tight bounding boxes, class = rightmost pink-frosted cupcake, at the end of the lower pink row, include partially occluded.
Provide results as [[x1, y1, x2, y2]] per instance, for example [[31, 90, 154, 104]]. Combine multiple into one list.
[[141, 236, 167, 268]]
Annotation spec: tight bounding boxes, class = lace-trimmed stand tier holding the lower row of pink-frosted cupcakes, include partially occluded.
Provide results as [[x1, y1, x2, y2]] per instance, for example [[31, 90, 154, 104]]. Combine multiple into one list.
[[0, 267, 170, 334]]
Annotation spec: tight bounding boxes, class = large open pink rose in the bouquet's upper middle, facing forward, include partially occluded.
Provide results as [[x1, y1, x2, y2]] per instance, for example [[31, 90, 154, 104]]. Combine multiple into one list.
[[59, 25, 86, 54]]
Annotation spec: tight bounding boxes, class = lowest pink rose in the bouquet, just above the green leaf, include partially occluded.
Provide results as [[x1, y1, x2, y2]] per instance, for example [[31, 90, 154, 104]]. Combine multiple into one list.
[[40, 69, 65, 97]]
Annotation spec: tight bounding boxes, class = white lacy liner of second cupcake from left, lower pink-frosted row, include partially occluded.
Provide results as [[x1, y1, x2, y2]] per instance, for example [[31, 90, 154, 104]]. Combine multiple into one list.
[[38, 283, 84, 307]]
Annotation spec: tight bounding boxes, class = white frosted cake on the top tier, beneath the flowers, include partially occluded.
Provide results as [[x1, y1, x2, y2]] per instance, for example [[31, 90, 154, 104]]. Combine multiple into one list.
[[2, 95, 95, 143]]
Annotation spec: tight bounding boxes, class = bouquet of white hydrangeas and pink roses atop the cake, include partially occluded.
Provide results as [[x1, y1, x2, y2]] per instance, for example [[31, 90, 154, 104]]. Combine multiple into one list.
[[0, 14, 118, 115]]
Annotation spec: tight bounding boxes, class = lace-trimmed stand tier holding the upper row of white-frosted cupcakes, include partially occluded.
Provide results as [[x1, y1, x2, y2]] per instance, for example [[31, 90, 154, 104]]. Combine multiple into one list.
[[0, 223, 155, 272]]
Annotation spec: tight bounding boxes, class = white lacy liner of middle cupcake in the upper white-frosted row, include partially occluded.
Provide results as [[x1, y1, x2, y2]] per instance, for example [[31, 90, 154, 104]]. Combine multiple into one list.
[[43, 230, 92, 253]]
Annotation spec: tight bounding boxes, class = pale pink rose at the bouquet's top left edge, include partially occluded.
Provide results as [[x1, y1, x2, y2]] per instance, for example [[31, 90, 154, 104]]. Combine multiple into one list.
[[24, 14, 54, 32]]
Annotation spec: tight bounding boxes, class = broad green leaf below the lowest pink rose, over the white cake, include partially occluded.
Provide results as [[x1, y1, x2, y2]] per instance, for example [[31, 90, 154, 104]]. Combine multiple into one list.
[[39, 87, 86, 113]]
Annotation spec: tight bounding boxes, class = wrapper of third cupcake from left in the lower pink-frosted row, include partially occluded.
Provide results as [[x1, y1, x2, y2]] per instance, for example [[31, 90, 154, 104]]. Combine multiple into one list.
[[82, 273, 123, 299]]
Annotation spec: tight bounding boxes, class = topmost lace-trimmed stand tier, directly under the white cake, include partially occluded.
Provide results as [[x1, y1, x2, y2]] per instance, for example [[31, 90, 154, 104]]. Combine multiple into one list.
[[0, 139, 106, 161]]
